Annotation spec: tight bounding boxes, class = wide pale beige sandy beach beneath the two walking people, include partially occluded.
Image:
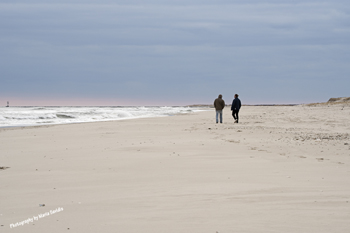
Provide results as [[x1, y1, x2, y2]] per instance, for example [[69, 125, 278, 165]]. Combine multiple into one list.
[[0, 105, 350, 233]]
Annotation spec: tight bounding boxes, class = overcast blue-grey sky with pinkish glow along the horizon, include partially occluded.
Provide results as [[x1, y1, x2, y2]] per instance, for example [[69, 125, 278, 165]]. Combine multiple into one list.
[[0, 0, 350, 106]]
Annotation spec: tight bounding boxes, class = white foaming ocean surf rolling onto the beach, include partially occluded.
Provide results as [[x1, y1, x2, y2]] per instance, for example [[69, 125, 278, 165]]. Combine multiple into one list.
[[0, 107, 201, 127]]
